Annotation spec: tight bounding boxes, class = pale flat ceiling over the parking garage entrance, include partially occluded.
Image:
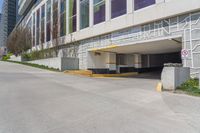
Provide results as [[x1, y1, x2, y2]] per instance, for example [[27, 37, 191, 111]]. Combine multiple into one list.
[[90, 38, 182, 54]]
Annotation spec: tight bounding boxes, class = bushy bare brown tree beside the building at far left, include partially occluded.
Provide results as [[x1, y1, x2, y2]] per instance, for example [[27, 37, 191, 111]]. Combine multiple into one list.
[[7, 26, 32, 55]]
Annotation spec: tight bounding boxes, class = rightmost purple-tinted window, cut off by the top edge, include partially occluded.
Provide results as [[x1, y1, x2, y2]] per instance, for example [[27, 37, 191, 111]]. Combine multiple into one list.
[[134, 0, 156, 10]]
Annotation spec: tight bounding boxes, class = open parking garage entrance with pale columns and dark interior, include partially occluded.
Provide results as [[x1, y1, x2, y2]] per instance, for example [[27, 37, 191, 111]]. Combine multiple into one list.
[[88, 38, 182, 77]]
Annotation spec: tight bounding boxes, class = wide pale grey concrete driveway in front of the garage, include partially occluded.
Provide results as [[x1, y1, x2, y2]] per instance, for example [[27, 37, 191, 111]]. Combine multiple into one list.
[[0, 62, 200, 133]]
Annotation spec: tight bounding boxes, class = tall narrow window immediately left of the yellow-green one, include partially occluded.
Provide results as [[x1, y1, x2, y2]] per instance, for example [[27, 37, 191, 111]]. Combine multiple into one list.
[[60, 0, 66, 36]]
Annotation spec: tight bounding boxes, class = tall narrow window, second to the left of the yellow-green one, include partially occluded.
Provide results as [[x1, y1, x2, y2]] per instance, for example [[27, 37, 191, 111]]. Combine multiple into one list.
[[53, 0, 58, 39]]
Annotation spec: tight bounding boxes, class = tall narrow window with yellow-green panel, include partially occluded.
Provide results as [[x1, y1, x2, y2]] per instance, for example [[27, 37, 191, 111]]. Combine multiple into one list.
[[69, 0, 77, 33]]
